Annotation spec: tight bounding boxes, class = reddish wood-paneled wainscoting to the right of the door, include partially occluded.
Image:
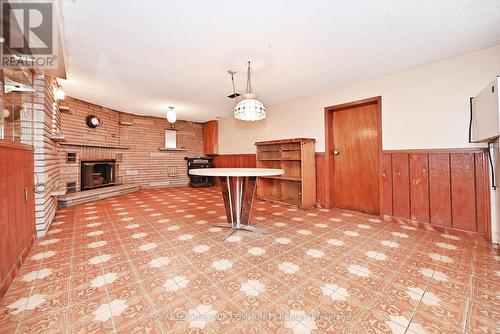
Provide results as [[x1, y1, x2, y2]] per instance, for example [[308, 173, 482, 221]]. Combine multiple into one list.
[[380, 149, 491, 240]]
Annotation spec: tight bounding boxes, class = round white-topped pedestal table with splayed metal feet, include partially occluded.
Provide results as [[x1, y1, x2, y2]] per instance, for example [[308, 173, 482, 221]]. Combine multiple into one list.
[[189, 168, 284, 240]]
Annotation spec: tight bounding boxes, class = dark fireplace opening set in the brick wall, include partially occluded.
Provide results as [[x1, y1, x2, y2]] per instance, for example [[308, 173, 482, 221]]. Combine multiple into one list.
[[81, 160, 116, 191]]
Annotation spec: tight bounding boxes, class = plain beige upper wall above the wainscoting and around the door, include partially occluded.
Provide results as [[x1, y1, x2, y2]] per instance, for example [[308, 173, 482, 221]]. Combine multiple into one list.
[[219, 45, 500, 154]]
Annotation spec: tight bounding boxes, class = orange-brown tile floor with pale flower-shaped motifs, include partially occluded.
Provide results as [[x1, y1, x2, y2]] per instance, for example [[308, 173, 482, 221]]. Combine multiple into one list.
[[0, 188, 500, 334]]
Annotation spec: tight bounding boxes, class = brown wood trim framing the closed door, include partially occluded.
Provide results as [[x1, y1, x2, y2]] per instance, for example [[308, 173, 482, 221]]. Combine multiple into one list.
[[324, 96, 383, 212]]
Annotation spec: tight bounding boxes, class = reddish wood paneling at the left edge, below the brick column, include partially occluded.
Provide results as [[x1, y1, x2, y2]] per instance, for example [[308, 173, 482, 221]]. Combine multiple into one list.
[[0, 140, 35, 299]]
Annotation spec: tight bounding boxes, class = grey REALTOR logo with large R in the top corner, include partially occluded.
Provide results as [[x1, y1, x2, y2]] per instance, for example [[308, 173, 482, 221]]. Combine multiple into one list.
[[0, 0, 58, 69]]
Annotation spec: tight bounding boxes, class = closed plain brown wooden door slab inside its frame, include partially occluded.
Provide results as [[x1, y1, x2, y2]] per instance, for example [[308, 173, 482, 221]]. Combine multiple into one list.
[[332, 102, 380, 214]]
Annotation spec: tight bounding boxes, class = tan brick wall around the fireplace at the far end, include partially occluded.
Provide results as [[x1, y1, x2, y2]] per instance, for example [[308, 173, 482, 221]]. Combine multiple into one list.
[[59, 97, 203, 189]]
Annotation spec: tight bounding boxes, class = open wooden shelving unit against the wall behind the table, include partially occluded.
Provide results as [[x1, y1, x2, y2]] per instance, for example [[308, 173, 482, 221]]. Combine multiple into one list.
[[255, 138, 316, 208]]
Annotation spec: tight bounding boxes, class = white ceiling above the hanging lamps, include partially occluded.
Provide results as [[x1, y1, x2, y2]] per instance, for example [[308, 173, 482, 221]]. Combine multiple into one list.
[[62, 0, 500, 121]]
